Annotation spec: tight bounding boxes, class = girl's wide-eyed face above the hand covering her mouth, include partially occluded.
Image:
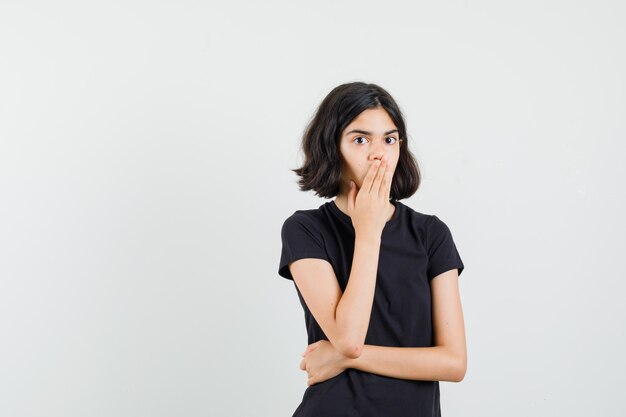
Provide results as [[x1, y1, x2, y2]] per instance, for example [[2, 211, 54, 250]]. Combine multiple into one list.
[[339, 108, 400, 190]]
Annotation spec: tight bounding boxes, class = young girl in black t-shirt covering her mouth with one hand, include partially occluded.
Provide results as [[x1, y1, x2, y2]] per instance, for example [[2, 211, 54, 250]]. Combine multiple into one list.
[[278, 82, 467, 417]]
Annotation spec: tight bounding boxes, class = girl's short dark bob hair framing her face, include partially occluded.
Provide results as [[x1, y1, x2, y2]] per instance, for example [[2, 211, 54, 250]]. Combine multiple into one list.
[[291, 82, 421, 201]]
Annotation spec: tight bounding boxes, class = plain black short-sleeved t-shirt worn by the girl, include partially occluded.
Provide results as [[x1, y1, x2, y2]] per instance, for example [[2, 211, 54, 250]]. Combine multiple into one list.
[[278, 200, 464, 417]]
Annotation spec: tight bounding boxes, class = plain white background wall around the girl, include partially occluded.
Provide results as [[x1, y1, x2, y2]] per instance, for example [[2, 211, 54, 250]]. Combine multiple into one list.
[[0, 0, 626, 417]]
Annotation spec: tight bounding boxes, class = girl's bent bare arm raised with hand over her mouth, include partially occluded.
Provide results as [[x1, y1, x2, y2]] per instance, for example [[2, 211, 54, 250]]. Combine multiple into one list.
[[289, 160, 393, 358]]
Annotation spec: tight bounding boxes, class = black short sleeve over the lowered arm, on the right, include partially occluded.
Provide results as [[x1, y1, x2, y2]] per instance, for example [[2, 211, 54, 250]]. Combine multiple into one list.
[[427, 215, 465, 281]]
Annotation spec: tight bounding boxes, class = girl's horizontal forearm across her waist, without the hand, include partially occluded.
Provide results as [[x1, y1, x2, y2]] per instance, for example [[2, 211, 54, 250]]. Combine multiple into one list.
[[346, 345, 466, 382]]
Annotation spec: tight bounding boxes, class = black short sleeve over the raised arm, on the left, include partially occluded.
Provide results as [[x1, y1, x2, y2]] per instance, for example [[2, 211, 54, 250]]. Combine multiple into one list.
[[278, 212, 330, 281]]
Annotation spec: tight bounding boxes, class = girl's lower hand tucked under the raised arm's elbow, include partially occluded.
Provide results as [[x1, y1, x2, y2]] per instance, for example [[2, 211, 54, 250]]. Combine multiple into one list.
[[300, 340, 349, 386]]
